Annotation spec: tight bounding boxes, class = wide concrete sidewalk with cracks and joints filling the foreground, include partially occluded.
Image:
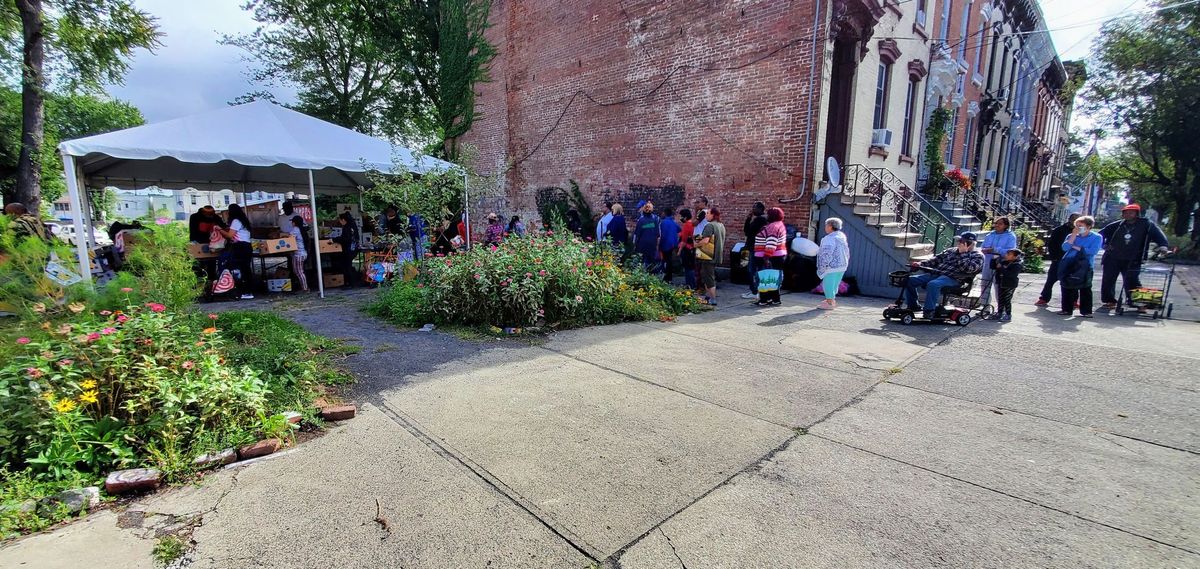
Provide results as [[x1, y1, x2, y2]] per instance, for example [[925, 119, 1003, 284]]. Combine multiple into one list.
[[0, 278, 1200, 569]]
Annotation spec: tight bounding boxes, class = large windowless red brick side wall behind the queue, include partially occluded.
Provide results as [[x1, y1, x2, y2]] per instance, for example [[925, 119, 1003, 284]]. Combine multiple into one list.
[[466, 0, 826, 241]]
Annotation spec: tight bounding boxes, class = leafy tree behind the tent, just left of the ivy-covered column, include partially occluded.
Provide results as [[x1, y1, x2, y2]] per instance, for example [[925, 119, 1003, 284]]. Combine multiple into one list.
[[222, 0, 421, 138]]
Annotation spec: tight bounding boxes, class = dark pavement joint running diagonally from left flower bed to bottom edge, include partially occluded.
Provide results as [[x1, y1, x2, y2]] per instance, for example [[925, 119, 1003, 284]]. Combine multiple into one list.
[[374, 397, 604, 561]]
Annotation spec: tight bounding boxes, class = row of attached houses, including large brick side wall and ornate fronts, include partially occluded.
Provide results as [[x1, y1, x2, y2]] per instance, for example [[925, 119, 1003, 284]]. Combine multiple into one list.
[[464, 0, 1069, 248]]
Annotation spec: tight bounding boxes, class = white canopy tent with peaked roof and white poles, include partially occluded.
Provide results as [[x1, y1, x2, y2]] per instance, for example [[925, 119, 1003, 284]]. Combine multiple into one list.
[[59, 101, 469, 297]]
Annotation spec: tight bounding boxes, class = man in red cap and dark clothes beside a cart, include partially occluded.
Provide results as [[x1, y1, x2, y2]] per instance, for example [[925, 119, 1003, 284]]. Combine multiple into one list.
[[1100, 204, 1166, 310]]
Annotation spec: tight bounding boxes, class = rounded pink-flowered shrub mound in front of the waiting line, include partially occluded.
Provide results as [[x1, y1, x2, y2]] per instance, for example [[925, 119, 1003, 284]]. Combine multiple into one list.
[[372, 232, 700, 327]]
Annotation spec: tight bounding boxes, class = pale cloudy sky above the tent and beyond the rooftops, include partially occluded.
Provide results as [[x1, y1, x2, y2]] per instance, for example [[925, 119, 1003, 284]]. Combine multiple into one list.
[[108, 0, 1146, 122]]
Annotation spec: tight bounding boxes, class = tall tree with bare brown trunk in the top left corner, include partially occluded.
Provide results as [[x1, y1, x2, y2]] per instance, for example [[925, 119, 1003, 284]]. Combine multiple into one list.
[[0, 0, 160, 210]]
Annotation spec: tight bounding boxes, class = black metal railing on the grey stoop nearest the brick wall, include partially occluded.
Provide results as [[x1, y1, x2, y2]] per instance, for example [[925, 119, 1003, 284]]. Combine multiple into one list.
[[842, 164, 954, 252]]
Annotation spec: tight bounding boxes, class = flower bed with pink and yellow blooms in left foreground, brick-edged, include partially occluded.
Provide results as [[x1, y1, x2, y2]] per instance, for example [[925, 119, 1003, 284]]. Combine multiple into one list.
[[0, 220, 349, 539]]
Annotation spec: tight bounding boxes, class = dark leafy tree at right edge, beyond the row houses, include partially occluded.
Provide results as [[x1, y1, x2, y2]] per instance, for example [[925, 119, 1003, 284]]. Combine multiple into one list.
[[1085, 2, 1200, 235]]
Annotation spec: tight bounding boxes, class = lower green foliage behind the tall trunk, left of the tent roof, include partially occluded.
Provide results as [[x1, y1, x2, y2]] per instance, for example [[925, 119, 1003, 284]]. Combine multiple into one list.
[[0, 85, 144, 202]]
